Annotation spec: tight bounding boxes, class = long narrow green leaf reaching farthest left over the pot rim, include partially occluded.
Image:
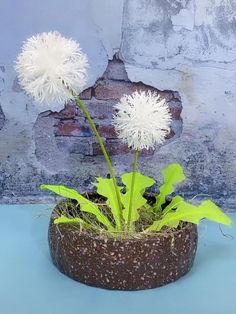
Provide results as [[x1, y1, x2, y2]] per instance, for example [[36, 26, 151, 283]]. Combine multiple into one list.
[[40, 184, 114, 232]]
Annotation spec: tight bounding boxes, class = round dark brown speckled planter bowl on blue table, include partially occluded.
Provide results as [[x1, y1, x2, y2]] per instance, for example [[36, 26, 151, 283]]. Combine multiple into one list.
[[48, 211, 198, 290]]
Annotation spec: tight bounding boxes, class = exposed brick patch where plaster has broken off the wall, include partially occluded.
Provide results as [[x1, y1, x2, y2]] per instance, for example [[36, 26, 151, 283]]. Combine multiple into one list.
[[34, 56, 182, 172]]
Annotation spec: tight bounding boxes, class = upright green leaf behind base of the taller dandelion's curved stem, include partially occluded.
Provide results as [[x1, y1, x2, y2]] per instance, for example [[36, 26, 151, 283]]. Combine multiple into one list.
[[94, 177, 122, 230]]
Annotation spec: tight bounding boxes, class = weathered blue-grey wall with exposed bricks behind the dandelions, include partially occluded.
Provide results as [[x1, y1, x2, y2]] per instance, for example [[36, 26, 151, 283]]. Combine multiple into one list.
[[0, 0, 236, 210]]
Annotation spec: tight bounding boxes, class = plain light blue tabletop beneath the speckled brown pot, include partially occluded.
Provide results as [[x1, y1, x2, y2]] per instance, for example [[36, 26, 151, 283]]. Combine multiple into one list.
[[0, 204, 236, 314]]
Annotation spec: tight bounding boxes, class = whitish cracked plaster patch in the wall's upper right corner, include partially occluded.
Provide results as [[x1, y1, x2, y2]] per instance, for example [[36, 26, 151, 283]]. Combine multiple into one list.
[[121, 0, 236, 64]]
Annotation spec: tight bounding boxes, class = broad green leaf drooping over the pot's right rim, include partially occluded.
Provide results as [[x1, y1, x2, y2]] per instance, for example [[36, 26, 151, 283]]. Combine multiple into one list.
[[147, 200, 232, 231]]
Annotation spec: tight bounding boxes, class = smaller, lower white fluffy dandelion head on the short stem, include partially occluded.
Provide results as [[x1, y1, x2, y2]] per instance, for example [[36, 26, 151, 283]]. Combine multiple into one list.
[[114, 91, 171, 150]]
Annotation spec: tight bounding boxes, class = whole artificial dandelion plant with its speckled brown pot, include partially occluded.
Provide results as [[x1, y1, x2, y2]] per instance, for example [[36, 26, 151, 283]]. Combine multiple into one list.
[[16, 32, 231, 290]]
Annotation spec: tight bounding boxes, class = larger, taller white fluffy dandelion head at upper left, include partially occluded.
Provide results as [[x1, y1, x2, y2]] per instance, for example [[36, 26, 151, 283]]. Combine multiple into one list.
[[16, 32, 88, 103]]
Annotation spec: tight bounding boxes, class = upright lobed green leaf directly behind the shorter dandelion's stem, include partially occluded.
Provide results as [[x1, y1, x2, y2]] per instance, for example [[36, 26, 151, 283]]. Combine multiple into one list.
[[121, 172, 155, 223]]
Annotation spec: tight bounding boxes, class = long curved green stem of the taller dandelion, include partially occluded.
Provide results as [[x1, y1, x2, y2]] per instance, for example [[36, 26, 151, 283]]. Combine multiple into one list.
[[72, 92, 122, 230]]
